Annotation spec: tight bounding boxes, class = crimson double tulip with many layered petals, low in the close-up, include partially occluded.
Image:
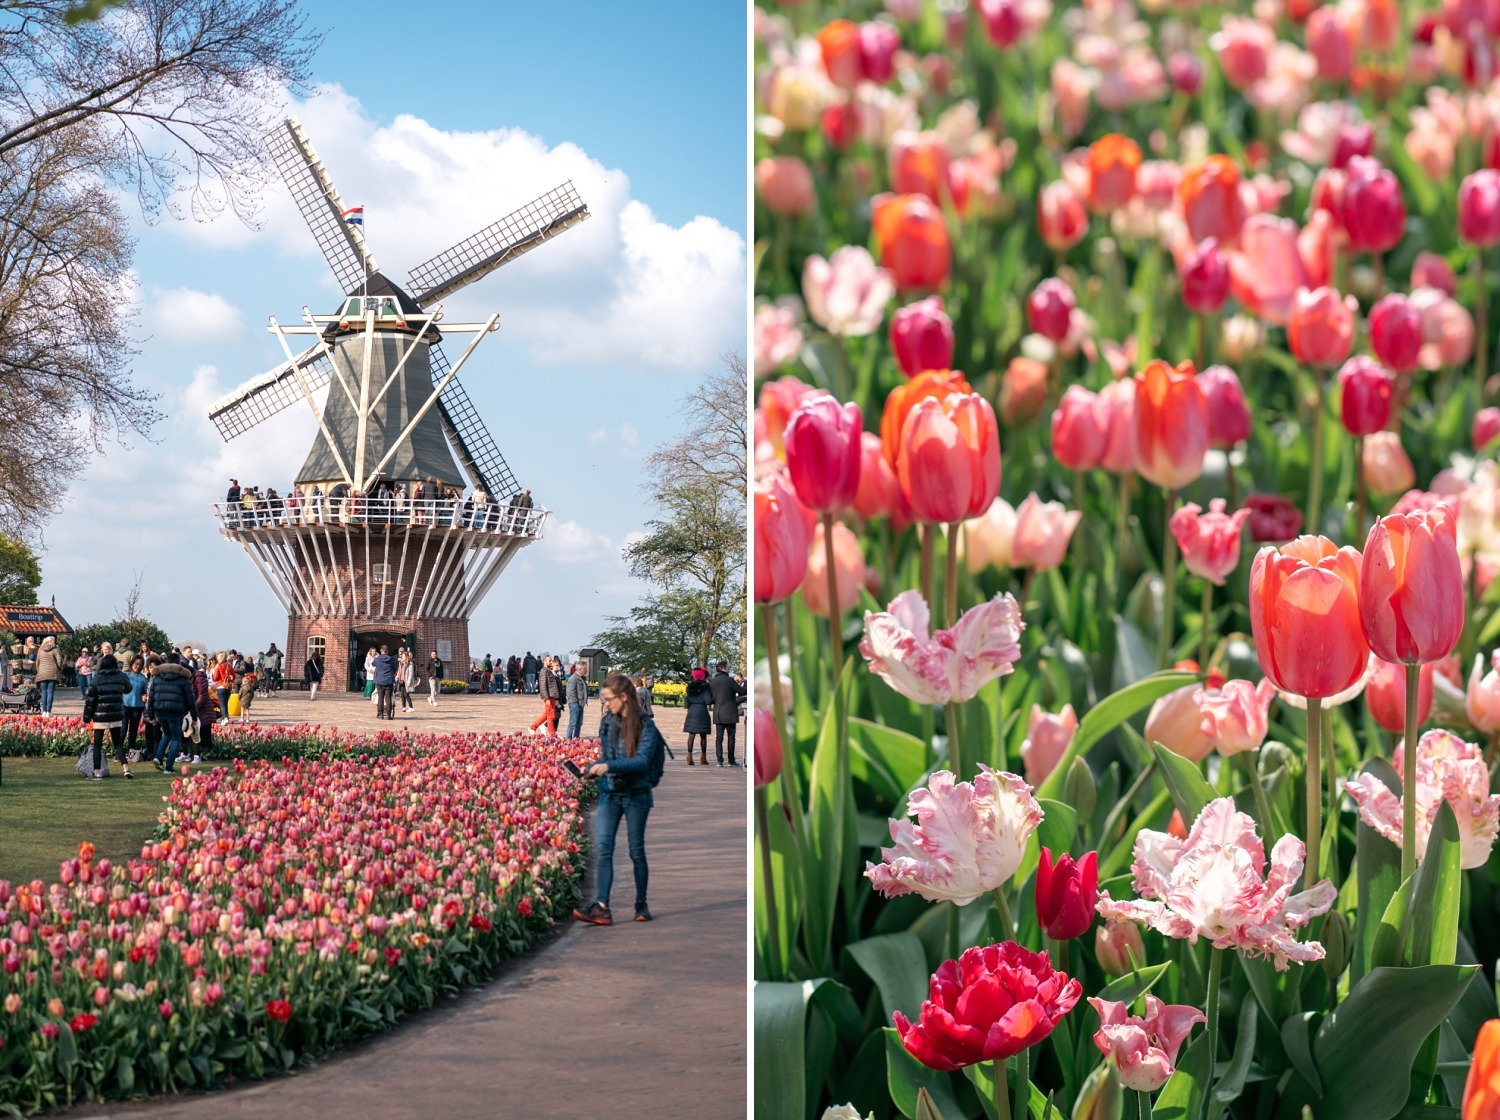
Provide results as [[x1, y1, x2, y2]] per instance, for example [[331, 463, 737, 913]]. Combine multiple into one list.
[[894, 942, 1083, 1072]]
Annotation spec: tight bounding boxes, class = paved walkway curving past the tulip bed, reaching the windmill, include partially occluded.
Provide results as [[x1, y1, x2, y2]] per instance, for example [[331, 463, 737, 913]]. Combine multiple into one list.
[[57, 694, 749, 1120]]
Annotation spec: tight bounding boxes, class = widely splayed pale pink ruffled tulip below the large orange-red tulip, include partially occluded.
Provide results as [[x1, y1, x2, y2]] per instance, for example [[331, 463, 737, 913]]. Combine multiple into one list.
[[1098, 798, 1344, 972]]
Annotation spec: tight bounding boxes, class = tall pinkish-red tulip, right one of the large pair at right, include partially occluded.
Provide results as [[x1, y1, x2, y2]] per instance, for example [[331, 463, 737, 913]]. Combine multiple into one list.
[[1359, 505, 1464, 664]]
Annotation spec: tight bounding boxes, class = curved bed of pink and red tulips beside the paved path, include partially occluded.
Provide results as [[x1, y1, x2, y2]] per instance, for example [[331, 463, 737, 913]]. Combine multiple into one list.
[[0, 735, 588, 1114]]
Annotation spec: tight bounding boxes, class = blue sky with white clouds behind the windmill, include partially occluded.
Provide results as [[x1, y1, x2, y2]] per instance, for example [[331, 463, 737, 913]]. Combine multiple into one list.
[[41, 3, 749, 655]]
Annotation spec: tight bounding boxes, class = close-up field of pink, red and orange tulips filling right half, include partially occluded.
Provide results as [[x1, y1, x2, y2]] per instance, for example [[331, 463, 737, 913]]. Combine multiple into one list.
[[752, 0, 1500, 1120]]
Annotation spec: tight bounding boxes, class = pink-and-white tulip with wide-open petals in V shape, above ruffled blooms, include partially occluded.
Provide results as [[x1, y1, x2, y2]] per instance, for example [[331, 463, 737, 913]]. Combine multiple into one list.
[[860, 591, 1026, 703]]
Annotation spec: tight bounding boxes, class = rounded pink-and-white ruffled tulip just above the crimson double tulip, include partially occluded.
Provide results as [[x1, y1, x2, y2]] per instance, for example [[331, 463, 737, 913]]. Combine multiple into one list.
[[864, 767, 1043, 906]]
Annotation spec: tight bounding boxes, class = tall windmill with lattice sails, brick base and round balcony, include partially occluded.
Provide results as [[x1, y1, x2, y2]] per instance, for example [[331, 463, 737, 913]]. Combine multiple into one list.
[[209, 118, 590, 688]]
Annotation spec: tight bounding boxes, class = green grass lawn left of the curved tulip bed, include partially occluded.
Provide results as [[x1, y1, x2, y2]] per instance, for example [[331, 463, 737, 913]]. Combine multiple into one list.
[[0, 759, 171, 883]]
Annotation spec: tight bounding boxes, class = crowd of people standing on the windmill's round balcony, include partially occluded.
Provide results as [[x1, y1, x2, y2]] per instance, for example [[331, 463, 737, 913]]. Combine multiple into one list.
[[221, 478, 540, 534]]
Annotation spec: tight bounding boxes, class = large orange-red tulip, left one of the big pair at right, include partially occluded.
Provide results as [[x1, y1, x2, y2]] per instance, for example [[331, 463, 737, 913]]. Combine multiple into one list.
[[1250, 537, 1370, 697]]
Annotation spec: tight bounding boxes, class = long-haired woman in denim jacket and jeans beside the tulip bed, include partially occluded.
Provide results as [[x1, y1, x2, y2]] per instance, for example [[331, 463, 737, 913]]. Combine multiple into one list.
[[573, 673, 666, 925]]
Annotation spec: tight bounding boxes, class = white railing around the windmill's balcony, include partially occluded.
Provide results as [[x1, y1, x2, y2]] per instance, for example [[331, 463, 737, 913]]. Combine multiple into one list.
[[213, 493, 549, 537]]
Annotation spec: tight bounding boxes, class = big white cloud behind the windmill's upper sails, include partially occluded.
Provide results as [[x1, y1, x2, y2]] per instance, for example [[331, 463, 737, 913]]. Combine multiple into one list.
[[159, 85, 746, 372]]
